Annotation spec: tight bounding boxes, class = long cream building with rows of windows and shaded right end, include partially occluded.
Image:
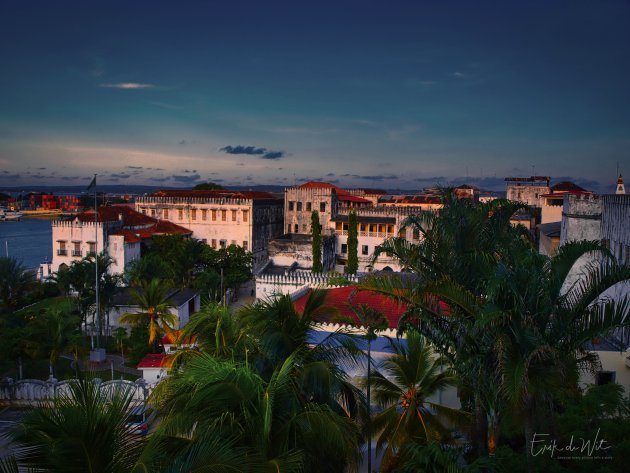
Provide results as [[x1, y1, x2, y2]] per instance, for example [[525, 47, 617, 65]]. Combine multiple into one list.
[[135, 190, 283, 268]]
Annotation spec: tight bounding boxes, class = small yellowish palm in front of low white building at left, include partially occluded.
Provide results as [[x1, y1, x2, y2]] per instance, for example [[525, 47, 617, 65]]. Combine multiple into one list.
[[120, 279, 177, 349]]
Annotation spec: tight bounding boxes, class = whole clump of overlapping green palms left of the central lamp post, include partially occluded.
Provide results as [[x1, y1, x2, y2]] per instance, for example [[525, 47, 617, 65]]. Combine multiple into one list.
[[141, 292, 361, 473]]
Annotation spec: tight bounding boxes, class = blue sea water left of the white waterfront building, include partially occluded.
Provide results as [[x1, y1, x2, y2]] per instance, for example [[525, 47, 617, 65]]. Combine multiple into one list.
[[0, 218, 52, 268]]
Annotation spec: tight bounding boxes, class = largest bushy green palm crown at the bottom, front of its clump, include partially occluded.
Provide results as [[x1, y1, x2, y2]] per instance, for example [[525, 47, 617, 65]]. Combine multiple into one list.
[[143, 353, 361, 472]]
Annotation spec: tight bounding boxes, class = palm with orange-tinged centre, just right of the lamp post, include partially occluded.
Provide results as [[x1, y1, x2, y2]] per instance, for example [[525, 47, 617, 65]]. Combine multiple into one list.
[[372, 333, 466, 471]]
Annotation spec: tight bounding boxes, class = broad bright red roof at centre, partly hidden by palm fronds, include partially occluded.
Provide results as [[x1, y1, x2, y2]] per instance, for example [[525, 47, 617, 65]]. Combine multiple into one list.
[[295, 286, 406, 328]]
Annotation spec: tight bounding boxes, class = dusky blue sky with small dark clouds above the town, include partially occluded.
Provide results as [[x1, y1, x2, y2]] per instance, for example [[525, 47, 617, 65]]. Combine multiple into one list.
[[0, 0, 630, 192]]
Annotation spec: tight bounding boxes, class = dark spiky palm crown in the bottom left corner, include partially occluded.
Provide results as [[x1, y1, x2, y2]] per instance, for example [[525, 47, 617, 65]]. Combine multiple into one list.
[[10, 378, 144, 473]]
